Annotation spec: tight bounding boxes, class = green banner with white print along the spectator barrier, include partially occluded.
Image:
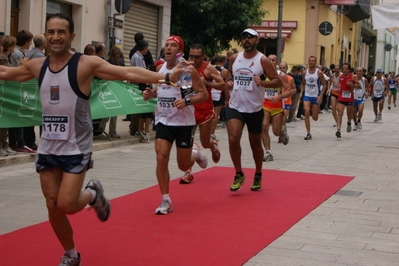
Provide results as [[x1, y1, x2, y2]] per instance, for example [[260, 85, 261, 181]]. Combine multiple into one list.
[[0, 80, 157, 128]]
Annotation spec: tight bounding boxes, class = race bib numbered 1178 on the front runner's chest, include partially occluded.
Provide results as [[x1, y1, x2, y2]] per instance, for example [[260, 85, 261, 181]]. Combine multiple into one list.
[[42, 115, 70, 140]]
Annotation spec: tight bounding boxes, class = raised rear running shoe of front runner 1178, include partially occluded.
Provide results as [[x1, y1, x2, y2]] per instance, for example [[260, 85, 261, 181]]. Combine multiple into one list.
[[85, 179, 111, 222]]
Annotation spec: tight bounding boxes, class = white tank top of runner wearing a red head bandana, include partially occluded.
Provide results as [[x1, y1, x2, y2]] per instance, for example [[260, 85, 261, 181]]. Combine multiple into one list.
[[155, 63, 196, 126]]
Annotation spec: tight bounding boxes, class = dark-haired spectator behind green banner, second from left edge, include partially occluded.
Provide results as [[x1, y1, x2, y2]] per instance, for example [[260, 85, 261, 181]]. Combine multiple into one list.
[[8, 30, 37, 153]]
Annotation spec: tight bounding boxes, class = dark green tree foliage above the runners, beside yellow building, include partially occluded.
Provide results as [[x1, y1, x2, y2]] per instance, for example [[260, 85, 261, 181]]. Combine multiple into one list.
[[171, 0, 266, 55]]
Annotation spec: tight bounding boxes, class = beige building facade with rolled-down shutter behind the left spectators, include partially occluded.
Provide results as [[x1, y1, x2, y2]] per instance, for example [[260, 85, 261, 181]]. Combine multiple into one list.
[[0, 0, 171, 62]]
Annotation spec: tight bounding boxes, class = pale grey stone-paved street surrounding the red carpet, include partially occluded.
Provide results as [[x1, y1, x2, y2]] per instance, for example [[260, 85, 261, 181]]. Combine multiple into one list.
[[0, 100, 399, 266]]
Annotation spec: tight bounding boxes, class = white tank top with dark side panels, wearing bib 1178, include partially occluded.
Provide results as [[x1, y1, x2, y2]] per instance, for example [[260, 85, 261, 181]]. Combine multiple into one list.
[[38, 53, 93, 155]]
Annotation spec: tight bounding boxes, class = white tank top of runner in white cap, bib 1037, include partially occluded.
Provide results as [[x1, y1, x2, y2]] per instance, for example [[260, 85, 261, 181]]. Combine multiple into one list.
[[229, 52, 265, 113]]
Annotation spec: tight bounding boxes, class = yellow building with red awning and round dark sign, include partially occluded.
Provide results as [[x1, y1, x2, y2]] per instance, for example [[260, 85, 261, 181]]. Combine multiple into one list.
[[233, 0, 369, 67]]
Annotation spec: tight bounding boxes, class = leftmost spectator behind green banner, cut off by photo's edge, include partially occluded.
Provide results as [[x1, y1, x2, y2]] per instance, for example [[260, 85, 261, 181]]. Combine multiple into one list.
[[0, 35, 17, 156]]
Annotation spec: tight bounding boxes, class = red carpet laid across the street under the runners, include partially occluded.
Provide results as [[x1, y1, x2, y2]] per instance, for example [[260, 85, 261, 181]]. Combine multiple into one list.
[[0, 167, 353, 266]]
